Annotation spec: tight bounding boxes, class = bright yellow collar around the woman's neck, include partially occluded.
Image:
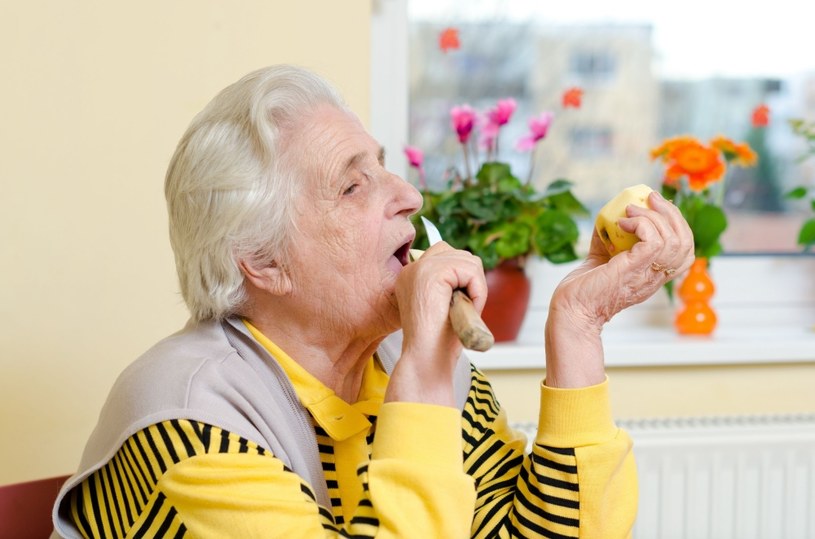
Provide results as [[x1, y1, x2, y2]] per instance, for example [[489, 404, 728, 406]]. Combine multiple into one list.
[[243, 320, 388, 442]]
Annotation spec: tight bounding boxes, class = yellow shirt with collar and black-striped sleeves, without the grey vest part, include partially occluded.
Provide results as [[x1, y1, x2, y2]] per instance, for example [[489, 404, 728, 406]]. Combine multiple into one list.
[[61, 322, 637, 539]]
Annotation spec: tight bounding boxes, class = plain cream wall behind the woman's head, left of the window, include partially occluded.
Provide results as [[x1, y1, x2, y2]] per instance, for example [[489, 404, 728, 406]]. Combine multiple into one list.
[[0, 0, 370, 484]]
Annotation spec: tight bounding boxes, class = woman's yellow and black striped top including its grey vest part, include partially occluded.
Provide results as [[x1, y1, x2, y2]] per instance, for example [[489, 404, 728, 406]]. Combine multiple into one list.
[[55, 320, 637, 538]]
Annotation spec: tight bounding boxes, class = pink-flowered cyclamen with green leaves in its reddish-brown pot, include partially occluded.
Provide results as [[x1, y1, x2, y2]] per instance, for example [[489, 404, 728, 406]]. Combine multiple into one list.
[[405, 99, 589, 342]]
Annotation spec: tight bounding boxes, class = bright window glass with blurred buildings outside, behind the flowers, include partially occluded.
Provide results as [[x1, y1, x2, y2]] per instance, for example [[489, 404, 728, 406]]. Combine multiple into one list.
[[372, 0, 815, 253]]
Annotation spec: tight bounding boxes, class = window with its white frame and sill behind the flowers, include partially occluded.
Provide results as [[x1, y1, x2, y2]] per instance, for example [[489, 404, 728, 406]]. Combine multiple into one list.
[[371, 0, 815, 369]]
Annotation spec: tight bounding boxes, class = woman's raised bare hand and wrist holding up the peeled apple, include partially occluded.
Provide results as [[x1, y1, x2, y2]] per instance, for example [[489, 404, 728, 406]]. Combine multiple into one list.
[[546, 192, 694, 387]]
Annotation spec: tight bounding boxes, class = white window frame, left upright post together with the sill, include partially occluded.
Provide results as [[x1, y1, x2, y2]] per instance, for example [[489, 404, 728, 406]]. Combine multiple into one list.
[[370, 0, 815, 370]]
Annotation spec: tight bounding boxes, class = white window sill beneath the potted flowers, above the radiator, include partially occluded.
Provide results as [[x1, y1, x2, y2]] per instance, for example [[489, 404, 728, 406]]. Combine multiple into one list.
[[468, 255, 815, 370]]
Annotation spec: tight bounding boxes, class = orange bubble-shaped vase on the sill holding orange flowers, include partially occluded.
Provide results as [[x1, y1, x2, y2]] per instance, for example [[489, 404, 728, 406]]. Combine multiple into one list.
[[674, 258, 717, 335]]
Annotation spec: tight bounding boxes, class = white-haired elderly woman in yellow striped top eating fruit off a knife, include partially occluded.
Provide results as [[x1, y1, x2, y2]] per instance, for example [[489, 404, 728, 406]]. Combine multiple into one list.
[[54, 66, 692, 538]]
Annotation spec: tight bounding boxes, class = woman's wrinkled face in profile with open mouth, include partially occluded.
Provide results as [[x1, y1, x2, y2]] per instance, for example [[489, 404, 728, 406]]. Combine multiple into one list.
[[280, 105, 422, 335]]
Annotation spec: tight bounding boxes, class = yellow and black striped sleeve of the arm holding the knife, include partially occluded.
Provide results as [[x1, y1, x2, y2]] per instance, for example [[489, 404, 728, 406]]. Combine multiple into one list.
[[68, 412, 475, 538]]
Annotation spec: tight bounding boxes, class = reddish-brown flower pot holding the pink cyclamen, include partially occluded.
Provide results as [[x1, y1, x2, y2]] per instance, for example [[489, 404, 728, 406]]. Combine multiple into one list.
[[481, 258, 532, 342]]
